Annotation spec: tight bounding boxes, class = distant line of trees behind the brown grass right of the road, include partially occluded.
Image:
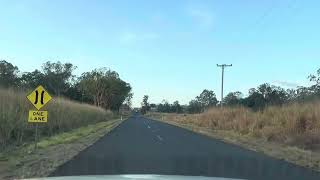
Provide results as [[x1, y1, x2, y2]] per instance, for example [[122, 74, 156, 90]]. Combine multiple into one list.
[[141, 69, 320, 113]]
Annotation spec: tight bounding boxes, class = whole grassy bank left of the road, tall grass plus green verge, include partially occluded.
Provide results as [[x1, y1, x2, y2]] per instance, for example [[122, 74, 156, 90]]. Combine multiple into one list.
[[0, 89, 125, 179]]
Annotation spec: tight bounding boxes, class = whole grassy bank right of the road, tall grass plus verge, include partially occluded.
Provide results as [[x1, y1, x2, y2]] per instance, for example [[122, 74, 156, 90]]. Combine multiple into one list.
[[148, 101, 320, 171]]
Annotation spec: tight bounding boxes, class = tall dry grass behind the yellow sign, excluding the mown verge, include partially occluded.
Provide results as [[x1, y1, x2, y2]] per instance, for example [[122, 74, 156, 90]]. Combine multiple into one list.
[[0, 89, 115, 150]]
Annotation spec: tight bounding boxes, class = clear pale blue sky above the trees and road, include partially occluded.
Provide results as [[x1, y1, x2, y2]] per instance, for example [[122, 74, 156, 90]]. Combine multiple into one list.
[[0, 0, 320, 106]]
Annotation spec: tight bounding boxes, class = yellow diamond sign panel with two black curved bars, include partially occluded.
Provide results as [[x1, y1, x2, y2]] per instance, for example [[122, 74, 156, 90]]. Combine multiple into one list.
[[27, 86, 52, 110]]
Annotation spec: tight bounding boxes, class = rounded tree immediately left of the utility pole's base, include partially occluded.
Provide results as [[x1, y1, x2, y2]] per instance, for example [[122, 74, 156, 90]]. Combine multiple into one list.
[[196, 89, 218, 111]]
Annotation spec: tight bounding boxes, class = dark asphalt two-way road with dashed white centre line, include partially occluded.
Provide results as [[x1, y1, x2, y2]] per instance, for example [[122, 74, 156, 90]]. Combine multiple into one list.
[[51, 115, 320, 180]]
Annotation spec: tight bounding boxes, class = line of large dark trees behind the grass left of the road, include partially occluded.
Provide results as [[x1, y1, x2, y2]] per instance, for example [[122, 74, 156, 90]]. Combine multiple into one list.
[[0, 60, 133, 111]]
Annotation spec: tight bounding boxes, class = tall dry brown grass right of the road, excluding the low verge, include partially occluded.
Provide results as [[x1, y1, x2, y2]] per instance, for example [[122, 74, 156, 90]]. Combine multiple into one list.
[[149, 101, 320, 150]]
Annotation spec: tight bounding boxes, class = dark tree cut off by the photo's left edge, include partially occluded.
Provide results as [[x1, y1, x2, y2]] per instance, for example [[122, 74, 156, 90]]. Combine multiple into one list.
[[0, 60, 20, 88]]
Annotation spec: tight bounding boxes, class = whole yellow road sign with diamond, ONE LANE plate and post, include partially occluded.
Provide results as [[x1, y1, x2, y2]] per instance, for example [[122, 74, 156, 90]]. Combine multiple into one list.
[[27, 85, 52, 149]]
